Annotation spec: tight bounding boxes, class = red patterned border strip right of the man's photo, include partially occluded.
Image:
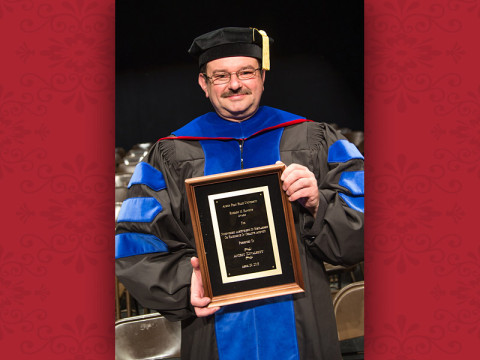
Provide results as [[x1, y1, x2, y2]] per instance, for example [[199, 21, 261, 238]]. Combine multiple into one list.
[[365, 0, 480, 360]]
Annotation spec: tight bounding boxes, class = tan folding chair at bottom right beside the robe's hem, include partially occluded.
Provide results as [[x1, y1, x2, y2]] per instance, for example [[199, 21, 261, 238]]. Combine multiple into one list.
[[333, 281, 365, 360]]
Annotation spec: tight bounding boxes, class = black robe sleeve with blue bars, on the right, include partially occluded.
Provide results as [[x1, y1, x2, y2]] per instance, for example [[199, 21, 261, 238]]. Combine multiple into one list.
[[301, 123, 364, 265]]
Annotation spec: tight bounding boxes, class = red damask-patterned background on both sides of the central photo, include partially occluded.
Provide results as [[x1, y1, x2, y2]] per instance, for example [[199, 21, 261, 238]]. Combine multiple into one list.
[[0, 0, 480, 360]]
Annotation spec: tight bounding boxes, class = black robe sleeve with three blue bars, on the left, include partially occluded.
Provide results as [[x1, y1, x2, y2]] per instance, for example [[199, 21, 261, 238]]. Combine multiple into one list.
[[115, 140, 196, 320]]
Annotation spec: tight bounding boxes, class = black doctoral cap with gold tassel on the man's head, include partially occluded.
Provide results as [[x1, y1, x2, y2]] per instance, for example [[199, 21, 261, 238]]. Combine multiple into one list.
[[188, 27, 273, 70]]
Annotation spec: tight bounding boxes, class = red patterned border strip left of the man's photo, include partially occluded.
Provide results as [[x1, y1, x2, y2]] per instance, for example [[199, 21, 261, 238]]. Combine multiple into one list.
[[0, 0, 115, 360]]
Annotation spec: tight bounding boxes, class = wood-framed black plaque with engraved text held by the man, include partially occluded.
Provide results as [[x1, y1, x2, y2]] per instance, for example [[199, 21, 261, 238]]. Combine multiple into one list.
[[185, 164, 304, 307]]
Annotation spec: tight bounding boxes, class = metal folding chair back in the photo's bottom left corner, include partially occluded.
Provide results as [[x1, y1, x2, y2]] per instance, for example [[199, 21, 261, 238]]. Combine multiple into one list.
[[115, 313, 181, 360]]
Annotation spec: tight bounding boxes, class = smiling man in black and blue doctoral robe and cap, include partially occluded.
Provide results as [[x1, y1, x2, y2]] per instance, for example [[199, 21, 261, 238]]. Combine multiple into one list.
[[116, 28, 363, 360]]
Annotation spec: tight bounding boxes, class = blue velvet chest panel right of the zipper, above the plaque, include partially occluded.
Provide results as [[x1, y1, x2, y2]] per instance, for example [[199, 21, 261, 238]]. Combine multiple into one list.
[[243, 128, 285, 169]]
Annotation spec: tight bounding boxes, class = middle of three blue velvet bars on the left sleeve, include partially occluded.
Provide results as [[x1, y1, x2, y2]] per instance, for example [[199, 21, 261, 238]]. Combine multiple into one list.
[[117, 197, 162, 222]]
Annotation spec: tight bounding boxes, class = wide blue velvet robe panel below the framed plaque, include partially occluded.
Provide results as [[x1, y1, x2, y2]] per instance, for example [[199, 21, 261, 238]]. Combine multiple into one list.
[[215, 295, 299, 360]]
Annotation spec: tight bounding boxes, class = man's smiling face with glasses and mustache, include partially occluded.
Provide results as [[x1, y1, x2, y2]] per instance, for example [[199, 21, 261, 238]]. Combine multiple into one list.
[[198, 56, 265, 121]]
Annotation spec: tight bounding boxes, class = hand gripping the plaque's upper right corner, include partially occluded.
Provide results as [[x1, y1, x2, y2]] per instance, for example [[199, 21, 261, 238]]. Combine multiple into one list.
[[277, 161, 319, 217]]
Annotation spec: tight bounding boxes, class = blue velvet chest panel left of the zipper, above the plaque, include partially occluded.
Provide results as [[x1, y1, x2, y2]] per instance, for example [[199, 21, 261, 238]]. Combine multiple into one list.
[[200, 140, 241, 175]]
